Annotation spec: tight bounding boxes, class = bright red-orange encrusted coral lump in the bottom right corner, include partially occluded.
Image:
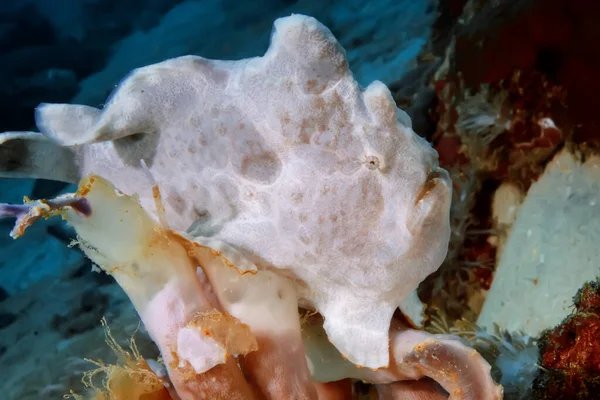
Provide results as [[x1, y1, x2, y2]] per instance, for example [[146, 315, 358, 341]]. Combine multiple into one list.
[[533, 281, 600, 400]]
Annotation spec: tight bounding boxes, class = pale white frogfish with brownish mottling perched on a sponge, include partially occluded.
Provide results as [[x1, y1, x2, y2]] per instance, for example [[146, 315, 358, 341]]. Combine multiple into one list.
[[0, 15, 451, 368]]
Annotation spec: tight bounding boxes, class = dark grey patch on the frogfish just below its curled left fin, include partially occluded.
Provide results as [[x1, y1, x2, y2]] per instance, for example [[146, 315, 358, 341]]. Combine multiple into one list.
[[113, 133, 159, 168]]
